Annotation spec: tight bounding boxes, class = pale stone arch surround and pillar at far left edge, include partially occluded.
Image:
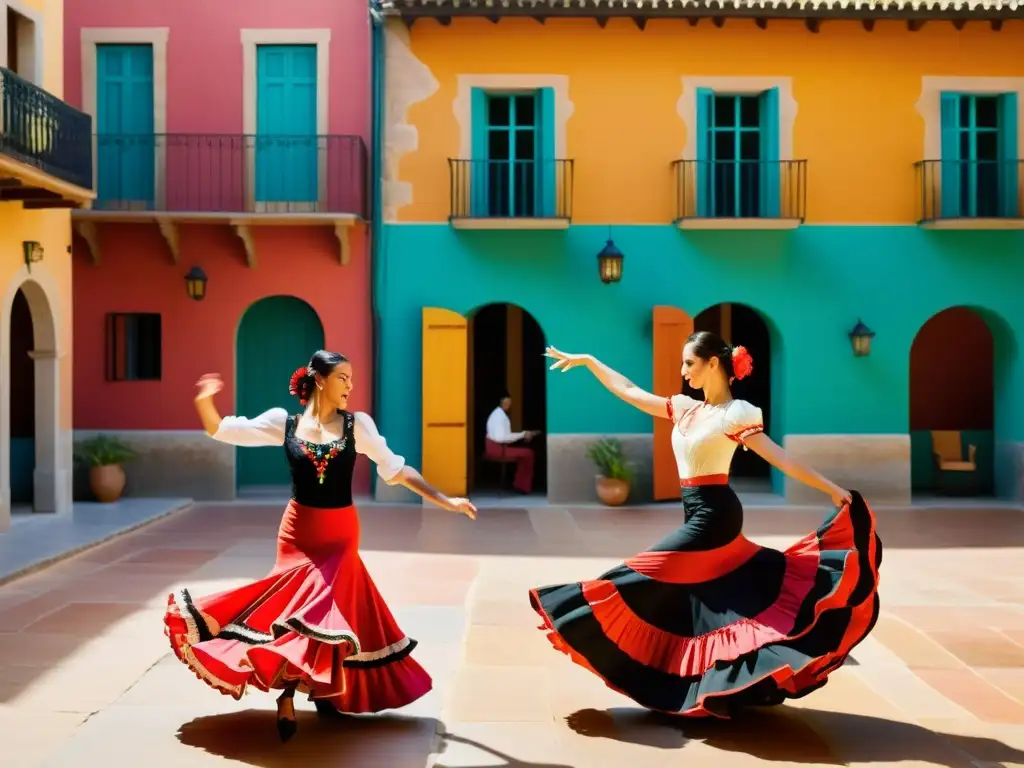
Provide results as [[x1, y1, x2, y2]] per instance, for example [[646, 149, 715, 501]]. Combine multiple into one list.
[[0, 267, 65, 528]]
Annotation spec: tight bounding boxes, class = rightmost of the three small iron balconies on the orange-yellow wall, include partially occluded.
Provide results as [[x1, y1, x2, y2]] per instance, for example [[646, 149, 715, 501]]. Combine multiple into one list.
[[914, 160, 1024, 229]]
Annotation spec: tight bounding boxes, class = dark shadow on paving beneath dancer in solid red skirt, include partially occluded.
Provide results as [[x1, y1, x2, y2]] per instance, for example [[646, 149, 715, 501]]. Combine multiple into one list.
[[177, 710, 443, 768]]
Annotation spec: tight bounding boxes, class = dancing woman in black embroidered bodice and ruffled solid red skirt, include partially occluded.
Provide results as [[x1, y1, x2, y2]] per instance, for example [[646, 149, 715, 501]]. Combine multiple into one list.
[[164, 350, 476, 741]]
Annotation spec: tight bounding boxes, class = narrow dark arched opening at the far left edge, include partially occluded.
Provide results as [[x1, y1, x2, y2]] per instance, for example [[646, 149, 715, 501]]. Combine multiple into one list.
[[10, 289, 36, 504]]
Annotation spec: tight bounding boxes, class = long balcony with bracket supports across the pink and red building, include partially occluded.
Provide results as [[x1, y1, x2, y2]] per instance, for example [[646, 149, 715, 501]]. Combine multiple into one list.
[[75, 133, 369, 266]]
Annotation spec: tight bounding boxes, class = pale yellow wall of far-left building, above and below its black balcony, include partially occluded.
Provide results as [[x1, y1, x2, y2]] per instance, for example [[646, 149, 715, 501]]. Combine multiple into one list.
[[0, 0, 72, 429]]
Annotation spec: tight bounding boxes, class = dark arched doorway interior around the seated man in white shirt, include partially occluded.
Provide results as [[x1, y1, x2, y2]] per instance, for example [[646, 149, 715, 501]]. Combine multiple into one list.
[[466, 304, 548, 494]]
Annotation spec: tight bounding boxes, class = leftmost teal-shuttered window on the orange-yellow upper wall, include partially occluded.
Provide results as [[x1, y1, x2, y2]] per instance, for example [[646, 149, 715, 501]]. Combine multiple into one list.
[[470, 88, 558, 218]]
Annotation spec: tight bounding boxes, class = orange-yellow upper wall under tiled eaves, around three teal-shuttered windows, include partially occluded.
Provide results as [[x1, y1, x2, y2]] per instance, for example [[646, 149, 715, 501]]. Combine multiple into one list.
[[387, 18, 1024, 223]]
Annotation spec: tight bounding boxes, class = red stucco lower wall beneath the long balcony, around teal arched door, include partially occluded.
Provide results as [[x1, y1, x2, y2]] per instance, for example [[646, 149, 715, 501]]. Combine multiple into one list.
[[74, 224, 373, 430]]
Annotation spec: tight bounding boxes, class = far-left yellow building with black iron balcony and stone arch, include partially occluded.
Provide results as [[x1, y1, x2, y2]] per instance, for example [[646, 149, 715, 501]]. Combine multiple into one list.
[[0, 0, 93, 531]]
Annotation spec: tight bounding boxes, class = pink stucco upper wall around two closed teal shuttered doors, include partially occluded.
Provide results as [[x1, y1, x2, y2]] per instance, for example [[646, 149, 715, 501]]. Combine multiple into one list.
[[63, 0, 371, 144]]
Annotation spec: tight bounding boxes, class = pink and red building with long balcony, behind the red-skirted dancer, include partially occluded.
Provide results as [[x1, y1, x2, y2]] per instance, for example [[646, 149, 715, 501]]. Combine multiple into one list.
[[66, 0, 373, 500]]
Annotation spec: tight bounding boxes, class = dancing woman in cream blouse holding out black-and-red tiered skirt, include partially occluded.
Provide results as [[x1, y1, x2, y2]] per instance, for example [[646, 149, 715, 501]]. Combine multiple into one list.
[[530, 332, 882, 718]]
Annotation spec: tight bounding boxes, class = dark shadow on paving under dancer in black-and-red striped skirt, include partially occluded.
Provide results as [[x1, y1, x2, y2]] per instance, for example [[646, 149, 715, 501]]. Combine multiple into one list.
[[565, 707, 1024, 768]]
